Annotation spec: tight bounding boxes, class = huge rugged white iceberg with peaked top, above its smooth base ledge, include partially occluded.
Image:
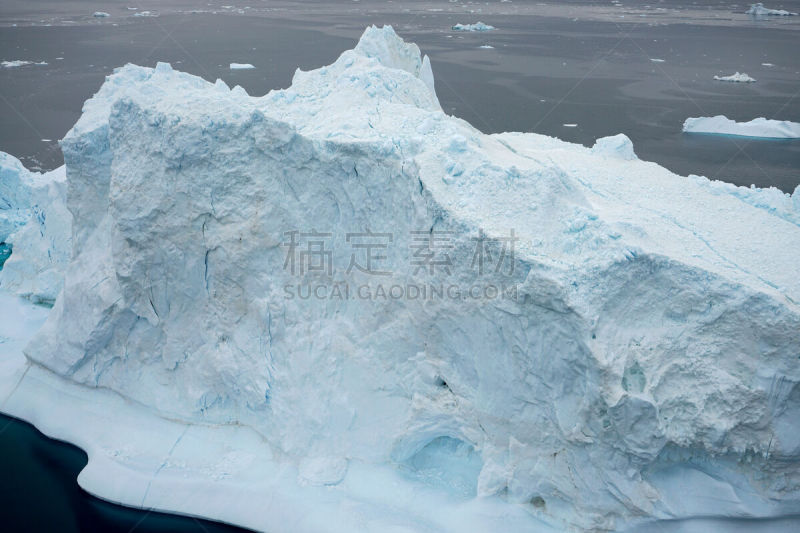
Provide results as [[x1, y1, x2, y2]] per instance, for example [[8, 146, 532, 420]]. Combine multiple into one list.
[[10, 23, 800, 529]]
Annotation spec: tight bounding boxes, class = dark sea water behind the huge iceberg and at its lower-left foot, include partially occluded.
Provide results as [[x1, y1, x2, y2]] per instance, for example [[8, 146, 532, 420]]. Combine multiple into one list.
[[0, 0, 800, 533]]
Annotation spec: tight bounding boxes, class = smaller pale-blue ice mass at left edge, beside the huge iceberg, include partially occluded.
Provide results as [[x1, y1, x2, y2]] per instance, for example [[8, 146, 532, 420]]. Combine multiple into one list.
[[0, 152, 72, 304]]
